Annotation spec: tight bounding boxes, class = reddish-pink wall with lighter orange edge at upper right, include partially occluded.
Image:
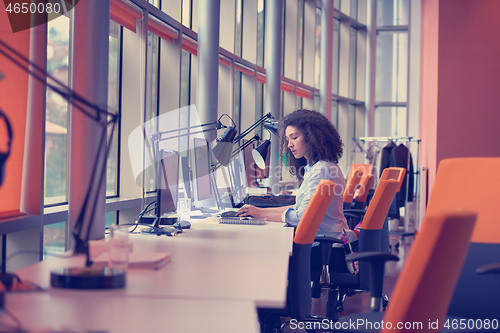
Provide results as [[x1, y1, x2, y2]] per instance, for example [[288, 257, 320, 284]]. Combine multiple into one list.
[[421, 0, 500, 188]]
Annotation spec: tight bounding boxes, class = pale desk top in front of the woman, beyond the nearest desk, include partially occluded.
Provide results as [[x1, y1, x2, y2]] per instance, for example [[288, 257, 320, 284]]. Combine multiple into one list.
[[18, 219, 293, 307]]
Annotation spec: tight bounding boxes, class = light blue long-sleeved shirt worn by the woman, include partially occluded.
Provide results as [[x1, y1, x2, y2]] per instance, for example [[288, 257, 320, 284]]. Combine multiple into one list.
[[281, 161, 348, 238]]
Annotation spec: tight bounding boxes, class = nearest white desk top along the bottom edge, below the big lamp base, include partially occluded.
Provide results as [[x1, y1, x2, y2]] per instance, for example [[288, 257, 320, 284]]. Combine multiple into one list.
[[0, 289, 259, 333]]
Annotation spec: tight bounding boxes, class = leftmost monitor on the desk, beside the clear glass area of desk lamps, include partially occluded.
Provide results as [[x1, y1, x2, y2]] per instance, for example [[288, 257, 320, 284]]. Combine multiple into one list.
[[156, 150, 179, 217]]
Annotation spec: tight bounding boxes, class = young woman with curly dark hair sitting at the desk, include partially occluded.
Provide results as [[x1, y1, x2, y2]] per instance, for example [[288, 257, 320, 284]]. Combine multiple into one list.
[[237, 110, 348, 239]]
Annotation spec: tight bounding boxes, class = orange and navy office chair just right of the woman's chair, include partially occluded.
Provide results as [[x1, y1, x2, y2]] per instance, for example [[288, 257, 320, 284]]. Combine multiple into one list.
[[316, 179, 399, 320]]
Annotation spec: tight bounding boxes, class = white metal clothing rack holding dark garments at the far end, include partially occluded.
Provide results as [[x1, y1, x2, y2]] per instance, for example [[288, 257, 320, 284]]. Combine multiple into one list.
[[351, 136, 421, 238]]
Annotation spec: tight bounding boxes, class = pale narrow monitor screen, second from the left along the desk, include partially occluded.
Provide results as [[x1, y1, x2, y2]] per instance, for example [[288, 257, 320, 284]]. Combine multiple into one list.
[[193, 138, 212, 201]]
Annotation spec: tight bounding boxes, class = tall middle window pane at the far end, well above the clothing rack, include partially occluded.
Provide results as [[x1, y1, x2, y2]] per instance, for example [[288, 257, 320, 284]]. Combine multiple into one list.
[[375, 32, 408, 102]]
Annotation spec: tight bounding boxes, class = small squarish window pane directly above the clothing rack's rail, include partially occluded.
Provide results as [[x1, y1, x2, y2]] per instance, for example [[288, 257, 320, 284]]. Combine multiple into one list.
[[374, 106, 407, 137]]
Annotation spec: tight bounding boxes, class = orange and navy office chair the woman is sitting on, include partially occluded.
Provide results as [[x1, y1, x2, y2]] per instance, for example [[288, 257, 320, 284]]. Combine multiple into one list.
[[258, 179, 337, 332]]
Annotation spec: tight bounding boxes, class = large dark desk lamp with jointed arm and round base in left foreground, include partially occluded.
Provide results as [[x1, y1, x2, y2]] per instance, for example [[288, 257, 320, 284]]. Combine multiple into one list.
[[0, 40, 125, 289]]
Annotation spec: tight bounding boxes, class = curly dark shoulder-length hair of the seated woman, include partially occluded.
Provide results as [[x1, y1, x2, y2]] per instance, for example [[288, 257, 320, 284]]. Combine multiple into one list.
[[281, 109, 344, 180]]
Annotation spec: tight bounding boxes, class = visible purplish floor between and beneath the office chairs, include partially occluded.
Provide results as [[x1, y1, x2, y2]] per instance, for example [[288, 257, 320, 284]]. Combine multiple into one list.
[[284, 235, 413, 333]]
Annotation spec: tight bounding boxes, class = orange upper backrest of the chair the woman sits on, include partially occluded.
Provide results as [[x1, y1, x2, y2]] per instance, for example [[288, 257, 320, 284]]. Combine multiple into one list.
[[293, 179, 337, 244]]
